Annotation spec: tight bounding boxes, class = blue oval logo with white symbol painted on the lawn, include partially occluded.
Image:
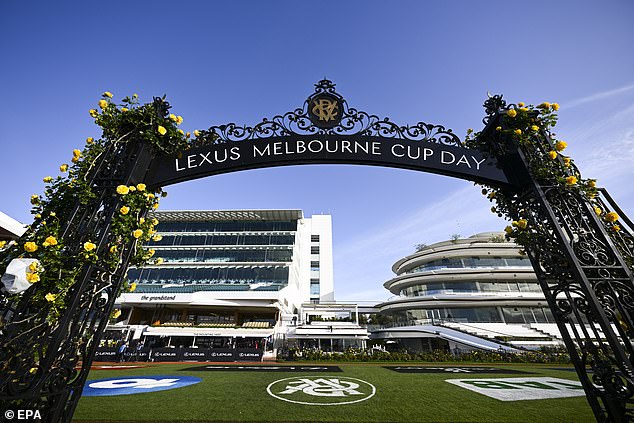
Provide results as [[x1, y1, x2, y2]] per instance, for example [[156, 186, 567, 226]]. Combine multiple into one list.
[[82, 375, 202, 397]]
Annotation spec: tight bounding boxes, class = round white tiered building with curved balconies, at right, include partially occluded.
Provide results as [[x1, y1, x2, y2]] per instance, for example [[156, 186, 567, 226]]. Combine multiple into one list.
[[372, 232, 563, 351]]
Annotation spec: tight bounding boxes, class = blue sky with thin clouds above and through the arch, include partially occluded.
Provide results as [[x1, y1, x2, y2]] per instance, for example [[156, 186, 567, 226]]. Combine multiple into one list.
[[0, 0, 634, 301]]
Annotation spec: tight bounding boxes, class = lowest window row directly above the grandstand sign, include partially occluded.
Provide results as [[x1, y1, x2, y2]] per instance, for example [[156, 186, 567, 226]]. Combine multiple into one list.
[[128, 267, 288, 284]]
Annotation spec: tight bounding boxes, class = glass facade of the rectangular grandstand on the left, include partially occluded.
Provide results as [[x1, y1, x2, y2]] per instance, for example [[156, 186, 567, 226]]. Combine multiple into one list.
[[128, 217, 297, 289]]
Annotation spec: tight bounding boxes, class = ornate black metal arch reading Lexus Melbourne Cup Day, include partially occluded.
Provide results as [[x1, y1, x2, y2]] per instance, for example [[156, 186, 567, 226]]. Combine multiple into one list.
[[0, 80, 634, 422]]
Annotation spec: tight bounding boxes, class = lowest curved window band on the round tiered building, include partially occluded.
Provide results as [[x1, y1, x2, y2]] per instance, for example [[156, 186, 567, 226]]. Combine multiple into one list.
[[394, 307, 555, 324]]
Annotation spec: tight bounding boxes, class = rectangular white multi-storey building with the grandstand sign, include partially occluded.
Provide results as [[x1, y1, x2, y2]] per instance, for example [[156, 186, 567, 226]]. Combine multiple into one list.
[[105, 210, 338, 361]]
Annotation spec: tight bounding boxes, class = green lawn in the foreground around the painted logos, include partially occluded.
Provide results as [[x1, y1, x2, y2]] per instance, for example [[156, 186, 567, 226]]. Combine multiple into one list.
[[75, 363, 594, 423]]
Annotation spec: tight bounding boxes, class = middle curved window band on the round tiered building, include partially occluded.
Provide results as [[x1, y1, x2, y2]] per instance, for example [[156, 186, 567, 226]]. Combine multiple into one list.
[[401, 281, 542, 297]]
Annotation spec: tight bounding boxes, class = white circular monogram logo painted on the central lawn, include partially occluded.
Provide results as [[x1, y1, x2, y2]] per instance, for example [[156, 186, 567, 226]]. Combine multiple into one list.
[[266, 376, 376, 405]]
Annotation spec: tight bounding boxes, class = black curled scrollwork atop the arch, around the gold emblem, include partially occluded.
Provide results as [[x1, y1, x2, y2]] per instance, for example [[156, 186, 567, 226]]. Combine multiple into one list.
[[195, 79, 462, 146]]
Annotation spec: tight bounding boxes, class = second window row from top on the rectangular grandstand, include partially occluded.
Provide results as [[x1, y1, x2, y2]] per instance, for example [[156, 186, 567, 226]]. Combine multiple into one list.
[[149, 233, 295, 246]]
